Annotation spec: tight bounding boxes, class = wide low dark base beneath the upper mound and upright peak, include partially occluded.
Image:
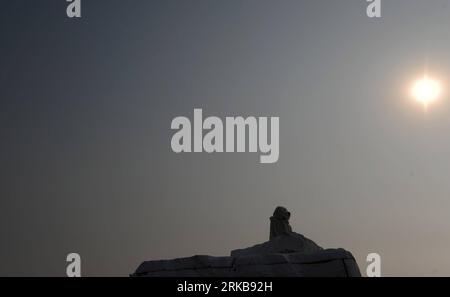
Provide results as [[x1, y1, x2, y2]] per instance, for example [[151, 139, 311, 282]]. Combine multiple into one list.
[[131, 249, 361, 277]]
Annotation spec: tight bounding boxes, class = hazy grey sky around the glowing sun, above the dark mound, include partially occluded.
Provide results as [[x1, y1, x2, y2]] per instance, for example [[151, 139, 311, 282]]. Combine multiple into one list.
[[0, 0, 450, 276]]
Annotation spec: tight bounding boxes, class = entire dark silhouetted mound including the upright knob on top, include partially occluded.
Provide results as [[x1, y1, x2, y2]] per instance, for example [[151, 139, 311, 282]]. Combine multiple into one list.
[[131, 206, 361, 278]]
